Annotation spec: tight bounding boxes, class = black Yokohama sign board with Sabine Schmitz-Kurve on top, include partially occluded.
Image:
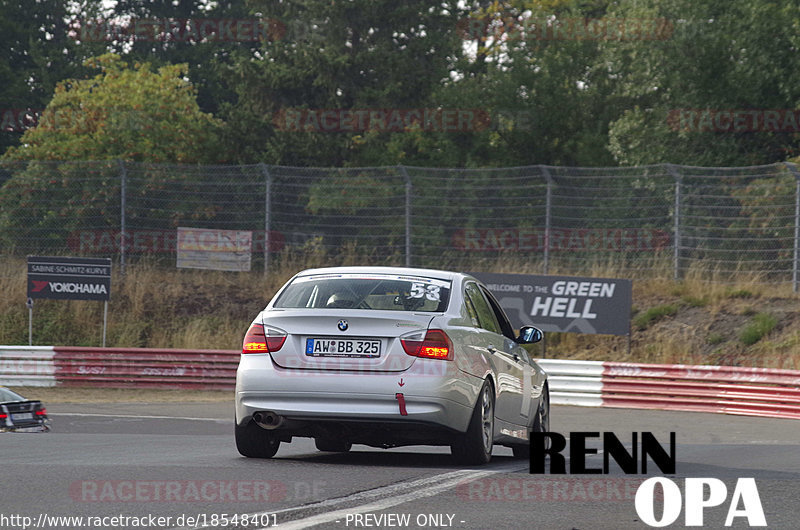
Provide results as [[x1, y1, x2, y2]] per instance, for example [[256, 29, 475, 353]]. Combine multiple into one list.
[[28, 256, 111, 300]]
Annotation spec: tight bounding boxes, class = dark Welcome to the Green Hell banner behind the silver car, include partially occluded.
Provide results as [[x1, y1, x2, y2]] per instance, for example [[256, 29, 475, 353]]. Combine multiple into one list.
[[470, 272, 633, 335]]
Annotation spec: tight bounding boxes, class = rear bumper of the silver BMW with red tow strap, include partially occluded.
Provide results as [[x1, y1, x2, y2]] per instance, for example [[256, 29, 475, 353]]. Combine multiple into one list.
[[236, 354, 482, 432]]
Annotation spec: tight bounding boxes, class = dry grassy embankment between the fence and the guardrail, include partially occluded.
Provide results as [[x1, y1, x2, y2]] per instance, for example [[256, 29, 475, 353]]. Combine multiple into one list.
[[0, 253, 800, 369]]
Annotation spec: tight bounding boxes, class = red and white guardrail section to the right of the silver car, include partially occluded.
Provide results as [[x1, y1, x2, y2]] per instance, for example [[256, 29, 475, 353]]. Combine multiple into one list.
[[538, 359, 800, 419]]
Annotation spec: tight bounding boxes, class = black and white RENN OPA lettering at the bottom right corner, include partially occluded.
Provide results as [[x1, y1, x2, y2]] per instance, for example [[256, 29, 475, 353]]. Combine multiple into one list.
[[530, 432, 767, 527]]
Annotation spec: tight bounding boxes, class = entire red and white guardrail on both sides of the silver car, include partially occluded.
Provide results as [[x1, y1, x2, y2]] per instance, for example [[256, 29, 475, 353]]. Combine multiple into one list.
[[0, 346, 800, 419]]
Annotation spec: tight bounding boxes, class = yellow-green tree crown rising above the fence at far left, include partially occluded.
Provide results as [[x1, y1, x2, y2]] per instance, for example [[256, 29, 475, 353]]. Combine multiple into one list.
[[4, 54, 221, 163]]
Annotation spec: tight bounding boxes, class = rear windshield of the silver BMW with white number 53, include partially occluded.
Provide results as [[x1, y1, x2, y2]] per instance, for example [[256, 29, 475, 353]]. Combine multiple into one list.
[[273, 274, 450, 312]]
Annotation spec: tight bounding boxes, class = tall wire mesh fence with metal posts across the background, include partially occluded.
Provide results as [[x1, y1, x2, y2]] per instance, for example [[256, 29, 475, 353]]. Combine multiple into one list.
[[0, 161, 800, 284]]
